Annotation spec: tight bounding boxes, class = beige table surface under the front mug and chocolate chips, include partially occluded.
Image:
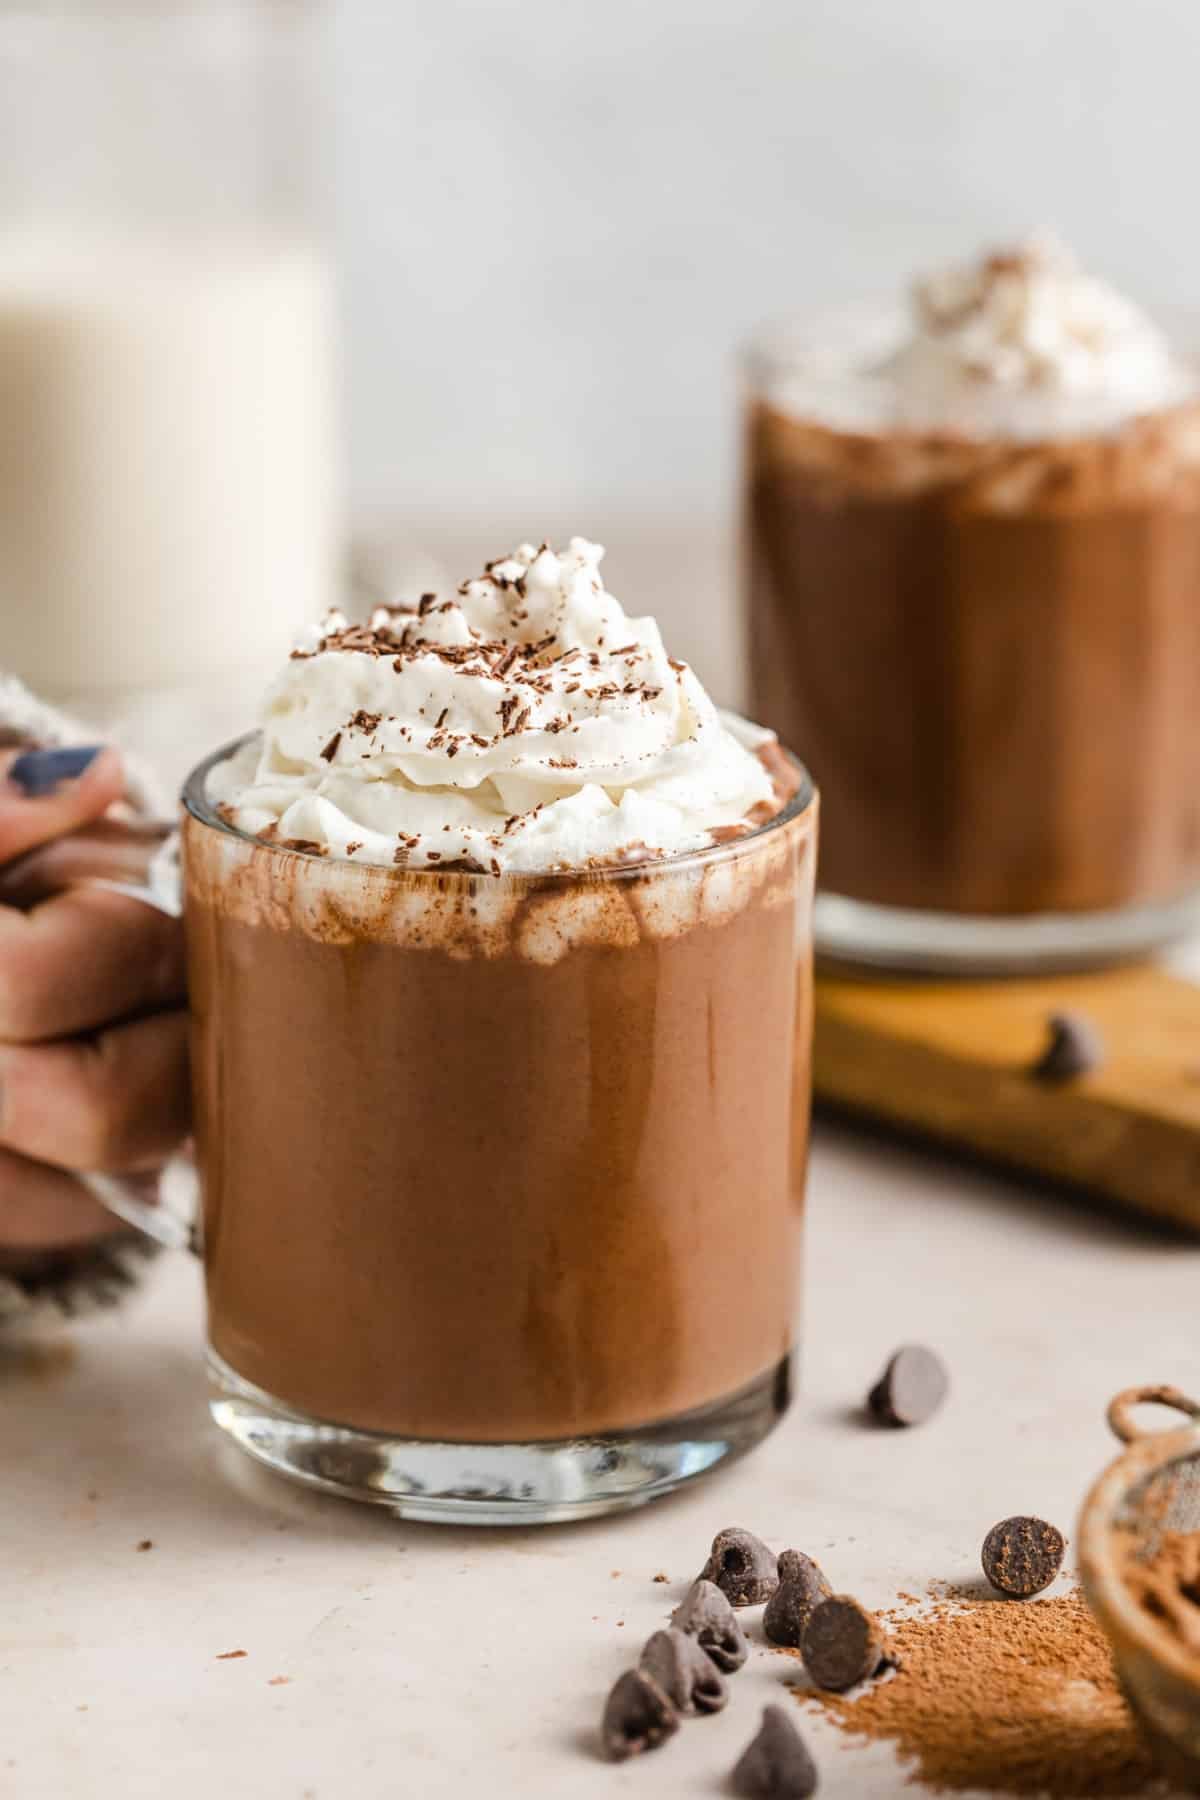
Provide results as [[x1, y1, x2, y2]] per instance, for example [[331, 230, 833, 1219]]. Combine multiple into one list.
[[0, 1127, 1200, 1800]]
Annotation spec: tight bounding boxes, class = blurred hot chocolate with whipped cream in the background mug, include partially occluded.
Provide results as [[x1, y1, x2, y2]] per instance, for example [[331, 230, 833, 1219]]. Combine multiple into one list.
[[748, 243, 1200, 964]]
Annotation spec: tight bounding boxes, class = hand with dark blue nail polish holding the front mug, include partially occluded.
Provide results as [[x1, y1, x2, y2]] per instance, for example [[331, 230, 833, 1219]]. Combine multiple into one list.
[[0, 749, 189, 1267]]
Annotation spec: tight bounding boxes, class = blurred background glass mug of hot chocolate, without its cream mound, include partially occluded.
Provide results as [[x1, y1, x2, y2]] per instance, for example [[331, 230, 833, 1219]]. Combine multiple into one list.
[[743, 306, 1200, 976]]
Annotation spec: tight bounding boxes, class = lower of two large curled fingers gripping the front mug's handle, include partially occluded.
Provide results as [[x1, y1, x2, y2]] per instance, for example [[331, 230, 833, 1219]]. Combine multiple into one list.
[[0, 1012, 191, 1174]]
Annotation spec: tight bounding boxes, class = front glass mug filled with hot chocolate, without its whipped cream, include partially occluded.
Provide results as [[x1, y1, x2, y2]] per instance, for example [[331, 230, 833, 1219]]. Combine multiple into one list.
[[47, 730, 817, 1523]]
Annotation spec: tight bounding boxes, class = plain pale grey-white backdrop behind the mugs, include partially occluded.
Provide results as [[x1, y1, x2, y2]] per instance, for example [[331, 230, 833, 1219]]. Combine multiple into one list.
[[333, 0, 1200, 684]]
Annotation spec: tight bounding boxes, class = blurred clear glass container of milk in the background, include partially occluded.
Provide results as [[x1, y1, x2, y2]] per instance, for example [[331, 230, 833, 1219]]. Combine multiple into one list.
[[0, 0, 336, 758]]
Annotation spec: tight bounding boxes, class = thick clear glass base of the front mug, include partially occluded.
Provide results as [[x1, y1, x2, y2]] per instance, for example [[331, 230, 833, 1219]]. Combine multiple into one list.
[[209, 1350, 793, 1525]]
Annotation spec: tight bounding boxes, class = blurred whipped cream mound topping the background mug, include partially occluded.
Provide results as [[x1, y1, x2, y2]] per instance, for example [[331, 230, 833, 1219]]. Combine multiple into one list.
[[766, 234, 1196, 439]]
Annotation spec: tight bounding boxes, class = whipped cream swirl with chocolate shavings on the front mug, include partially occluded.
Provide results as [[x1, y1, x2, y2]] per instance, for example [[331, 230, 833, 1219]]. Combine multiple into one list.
[[209, 538, 775, 875]]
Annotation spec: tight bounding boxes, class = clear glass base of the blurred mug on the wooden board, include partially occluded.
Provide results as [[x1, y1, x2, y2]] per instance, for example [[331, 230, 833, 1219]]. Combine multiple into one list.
[[813, 887, 1200, 976]]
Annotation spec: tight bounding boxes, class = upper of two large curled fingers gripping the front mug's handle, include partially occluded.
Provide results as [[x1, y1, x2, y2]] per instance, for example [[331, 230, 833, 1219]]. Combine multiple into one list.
[[0, 887, 184, 1044]]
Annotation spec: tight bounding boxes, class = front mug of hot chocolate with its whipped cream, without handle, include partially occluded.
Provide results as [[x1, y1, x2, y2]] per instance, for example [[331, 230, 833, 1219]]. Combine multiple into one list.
[[184, 540, 817, 1523]]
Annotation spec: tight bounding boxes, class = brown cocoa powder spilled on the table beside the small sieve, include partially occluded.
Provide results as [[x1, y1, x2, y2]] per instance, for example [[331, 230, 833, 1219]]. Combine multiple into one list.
[[799, 1589, 1162, 1800]]
